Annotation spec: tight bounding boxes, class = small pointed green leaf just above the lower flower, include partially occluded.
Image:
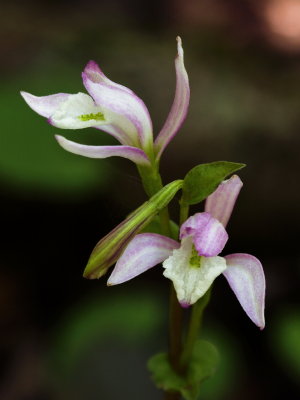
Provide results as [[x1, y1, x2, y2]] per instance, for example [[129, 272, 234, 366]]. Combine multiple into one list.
[[181, 161, 246, 205]]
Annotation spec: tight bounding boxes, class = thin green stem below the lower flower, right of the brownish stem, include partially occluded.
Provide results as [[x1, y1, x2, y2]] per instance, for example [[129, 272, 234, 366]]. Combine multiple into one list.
[[181, 289, 211, 372]]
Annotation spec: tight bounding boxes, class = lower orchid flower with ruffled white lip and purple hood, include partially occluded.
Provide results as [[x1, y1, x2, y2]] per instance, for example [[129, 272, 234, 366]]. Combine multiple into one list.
[[108, 175, 265, 329]]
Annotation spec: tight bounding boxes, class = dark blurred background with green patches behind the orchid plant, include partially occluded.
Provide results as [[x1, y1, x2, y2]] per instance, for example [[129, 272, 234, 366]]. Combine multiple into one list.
[[0, 0, 300, 400]]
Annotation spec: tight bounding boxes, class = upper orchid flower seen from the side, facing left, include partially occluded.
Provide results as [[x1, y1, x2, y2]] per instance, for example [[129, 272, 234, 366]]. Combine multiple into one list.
[[21, 37, 190, 166]]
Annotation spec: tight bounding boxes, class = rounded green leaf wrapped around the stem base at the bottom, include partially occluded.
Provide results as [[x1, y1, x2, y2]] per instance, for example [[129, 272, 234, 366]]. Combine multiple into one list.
[[148, 340, 219, 400]]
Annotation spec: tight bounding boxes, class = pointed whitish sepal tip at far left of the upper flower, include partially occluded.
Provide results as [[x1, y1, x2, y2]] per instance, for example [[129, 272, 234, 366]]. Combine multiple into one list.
[[21, 92, 71, 118]]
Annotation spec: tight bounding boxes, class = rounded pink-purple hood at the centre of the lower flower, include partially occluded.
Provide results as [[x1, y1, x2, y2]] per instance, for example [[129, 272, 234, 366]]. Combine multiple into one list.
[[180, 212, 228, 257]]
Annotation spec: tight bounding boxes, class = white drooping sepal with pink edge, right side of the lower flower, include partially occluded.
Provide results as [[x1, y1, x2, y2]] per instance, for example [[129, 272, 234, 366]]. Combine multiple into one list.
[[223, 254, 266, 329]]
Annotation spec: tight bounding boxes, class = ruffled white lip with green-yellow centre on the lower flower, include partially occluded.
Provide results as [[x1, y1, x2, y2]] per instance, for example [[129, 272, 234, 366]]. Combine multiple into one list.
[[163, 237, 226, 307]]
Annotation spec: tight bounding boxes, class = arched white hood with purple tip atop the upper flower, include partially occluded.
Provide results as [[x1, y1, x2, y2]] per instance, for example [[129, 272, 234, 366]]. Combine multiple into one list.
[[82, 62, 153, 151]]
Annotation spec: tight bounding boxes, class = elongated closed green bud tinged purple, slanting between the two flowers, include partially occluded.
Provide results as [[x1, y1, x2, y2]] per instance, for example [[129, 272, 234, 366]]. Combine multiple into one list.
[[83, 179, 183, 279]]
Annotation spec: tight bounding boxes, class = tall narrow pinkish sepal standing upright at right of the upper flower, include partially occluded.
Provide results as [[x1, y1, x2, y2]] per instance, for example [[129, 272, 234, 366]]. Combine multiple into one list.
[[155, 37, 190, 158]]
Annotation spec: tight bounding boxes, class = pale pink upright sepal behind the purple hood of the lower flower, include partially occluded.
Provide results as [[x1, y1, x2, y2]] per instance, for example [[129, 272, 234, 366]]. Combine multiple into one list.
[[205, 175, 243, 226]]
